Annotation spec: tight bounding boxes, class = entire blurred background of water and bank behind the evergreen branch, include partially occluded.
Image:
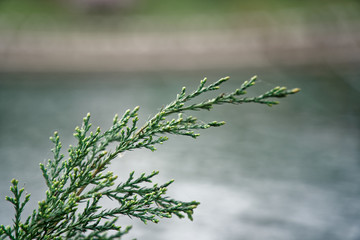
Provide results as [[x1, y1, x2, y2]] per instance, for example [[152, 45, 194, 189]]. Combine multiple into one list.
[[0, 0, 360, 240]]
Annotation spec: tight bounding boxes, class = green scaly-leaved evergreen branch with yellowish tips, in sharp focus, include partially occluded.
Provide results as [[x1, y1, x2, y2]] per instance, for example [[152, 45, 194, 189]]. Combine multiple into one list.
[[0, 74, 299, 240]]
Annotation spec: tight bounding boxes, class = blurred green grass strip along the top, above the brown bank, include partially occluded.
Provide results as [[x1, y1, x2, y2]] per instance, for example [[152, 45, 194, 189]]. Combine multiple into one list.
[[0, 0, 360, 31]]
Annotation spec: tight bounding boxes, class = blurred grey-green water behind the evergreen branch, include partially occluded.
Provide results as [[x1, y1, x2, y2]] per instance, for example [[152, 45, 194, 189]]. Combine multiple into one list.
[[0, 68, 360, 240]]
